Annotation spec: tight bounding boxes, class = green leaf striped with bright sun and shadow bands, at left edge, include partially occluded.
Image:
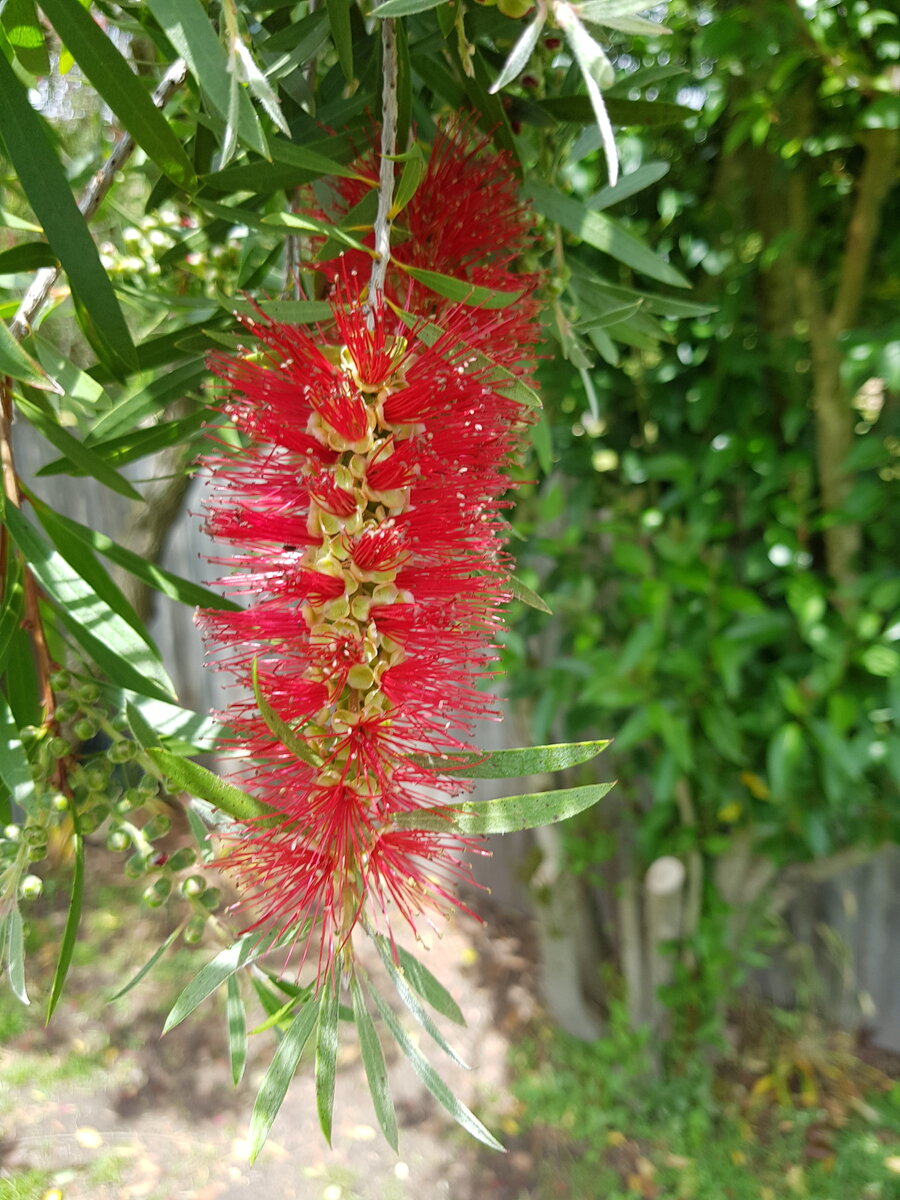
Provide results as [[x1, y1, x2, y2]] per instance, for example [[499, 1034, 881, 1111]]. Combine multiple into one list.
[[6, 504, 174, 700]]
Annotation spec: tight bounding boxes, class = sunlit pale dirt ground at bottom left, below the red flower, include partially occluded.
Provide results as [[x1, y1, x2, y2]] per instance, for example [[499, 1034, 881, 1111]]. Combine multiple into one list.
[[0, 873, 535, 1200]]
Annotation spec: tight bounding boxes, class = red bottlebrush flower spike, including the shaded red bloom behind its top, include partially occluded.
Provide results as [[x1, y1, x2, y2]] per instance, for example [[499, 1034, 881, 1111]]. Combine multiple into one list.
[[200, 133, 538, 978]]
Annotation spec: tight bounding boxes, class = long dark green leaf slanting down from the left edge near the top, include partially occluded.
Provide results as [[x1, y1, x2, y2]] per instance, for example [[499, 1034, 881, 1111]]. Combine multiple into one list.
[[0, 50, 135, 373]]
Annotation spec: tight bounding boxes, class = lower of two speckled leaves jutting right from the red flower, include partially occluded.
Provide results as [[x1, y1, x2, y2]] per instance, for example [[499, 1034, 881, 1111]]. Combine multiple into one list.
[[391, 781, 616, 838]]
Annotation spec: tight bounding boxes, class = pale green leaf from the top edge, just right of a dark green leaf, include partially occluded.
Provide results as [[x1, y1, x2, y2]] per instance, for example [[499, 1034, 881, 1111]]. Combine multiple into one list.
[[146, 0, 269, 158]]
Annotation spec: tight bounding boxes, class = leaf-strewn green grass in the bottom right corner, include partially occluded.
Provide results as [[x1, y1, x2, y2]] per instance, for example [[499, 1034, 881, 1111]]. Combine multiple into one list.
[[512, 1008, 900, 1200]]
